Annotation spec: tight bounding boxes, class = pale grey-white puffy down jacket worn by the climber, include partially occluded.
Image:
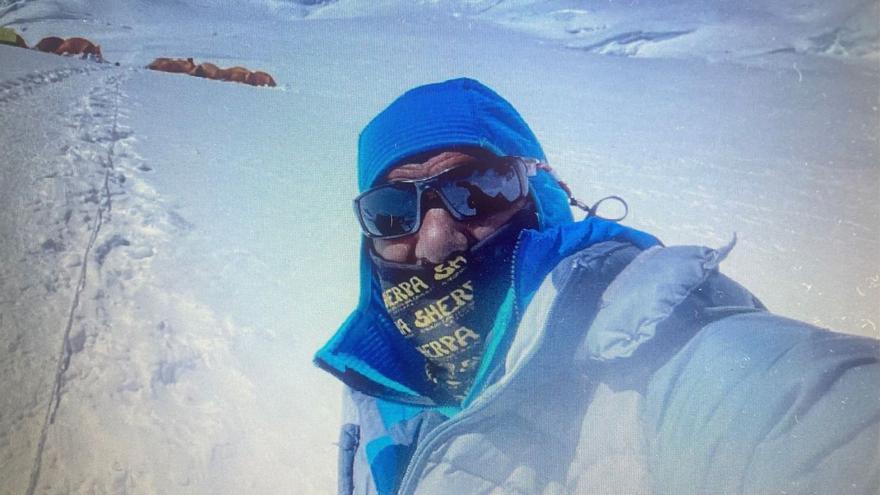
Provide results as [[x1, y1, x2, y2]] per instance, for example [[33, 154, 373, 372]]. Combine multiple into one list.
[[340, 242, 880, 495]]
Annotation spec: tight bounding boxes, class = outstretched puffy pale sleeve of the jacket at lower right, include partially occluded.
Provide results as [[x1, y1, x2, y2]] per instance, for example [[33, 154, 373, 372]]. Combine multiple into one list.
[[645, 312, 880, 494]]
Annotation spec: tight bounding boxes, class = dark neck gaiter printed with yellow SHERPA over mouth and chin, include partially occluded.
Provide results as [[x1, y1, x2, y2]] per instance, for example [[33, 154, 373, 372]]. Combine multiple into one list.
[[372, 206, 537, 403]]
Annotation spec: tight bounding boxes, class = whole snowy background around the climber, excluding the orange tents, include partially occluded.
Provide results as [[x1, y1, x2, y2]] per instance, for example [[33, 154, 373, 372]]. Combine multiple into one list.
[[0, 0, 880, 494]]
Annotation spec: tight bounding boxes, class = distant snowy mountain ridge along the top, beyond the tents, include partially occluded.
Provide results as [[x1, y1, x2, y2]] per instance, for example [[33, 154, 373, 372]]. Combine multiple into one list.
[[0, 0, 880, 63]]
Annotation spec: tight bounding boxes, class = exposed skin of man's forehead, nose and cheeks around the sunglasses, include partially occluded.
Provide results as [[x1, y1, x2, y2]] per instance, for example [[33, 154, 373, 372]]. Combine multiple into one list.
[[373, 151, 528, 264]]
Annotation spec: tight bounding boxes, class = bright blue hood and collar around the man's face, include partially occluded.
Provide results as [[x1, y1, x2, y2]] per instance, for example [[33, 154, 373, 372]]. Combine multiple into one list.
[[315, 79, 656, 406]]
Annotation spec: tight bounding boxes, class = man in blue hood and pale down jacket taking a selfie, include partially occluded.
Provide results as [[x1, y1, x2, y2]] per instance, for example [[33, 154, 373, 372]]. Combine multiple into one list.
[[315, 79, 880, 495]]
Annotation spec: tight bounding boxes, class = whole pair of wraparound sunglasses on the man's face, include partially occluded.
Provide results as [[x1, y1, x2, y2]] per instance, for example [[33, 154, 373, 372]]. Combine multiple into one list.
[[354, 157, 538, 239]]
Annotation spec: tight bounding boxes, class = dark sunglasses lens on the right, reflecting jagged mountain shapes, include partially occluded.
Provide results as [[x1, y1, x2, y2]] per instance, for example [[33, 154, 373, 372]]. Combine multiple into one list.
[[438, 164, 525, 217]]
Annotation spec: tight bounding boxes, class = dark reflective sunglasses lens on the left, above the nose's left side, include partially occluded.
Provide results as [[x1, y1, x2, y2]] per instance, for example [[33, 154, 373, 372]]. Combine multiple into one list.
[[358, 184, 419, 237]]
